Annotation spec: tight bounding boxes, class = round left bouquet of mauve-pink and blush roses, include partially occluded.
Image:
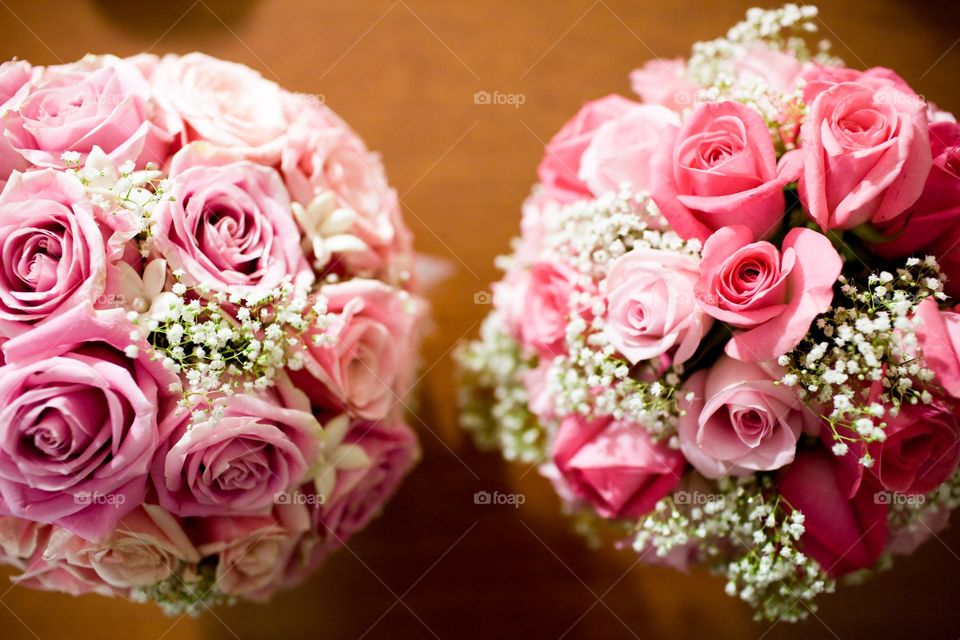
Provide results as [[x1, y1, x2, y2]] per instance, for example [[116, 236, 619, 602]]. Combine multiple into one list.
[[0, 53, 425, 613]]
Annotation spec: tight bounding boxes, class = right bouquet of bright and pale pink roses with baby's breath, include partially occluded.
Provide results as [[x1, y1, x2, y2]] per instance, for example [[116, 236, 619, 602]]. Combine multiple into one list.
[[460, 5, 960, 620]]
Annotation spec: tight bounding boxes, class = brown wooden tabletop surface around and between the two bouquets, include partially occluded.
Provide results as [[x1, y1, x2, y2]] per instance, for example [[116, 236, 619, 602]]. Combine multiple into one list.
[[0, 0, 960, 640]]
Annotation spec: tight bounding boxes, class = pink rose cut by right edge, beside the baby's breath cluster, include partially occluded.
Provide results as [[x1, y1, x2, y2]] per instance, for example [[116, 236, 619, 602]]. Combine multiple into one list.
[[916, 298, 960, 399]]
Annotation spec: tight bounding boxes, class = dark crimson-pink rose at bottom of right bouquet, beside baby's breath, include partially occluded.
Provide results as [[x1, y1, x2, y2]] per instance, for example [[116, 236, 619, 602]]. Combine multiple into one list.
[[778, 447, 887, 578]]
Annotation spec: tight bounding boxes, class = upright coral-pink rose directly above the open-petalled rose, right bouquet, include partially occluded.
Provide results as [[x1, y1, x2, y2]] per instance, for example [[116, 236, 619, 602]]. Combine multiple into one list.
[[651, 102, 789, 240]]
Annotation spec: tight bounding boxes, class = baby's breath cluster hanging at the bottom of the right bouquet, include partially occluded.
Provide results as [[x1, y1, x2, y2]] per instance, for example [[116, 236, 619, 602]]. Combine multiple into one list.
[[634, 476, 835, 622]]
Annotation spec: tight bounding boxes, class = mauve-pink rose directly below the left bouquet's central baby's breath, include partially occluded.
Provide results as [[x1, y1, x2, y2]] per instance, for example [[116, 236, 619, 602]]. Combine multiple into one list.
[[151, 376, 321, 517]]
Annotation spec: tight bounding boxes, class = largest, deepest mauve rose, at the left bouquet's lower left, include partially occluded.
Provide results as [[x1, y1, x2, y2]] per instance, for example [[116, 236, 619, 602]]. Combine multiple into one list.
[[0, 308, 179, 540]]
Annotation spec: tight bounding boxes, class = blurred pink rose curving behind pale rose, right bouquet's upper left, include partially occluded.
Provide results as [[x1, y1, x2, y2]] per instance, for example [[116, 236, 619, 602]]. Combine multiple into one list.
[[537, 95, 638, 203]]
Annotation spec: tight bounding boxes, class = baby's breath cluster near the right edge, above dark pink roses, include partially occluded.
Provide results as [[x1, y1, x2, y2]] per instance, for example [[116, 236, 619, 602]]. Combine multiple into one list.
[[780, 257, 945, 458]]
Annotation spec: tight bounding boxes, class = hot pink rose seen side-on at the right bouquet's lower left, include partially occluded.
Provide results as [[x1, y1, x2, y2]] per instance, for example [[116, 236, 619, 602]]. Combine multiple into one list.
[[552, 416, 686, 518]]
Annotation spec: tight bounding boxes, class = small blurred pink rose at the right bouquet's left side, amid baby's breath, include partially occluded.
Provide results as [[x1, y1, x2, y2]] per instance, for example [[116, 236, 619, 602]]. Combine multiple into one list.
[[520, 262, 580, 358]]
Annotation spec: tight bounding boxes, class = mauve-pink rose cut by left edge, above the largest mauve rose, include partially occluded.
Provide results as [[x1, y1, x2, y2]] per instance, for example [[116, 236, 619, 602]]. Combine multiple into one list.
[[0, 170, 107, 337]]
